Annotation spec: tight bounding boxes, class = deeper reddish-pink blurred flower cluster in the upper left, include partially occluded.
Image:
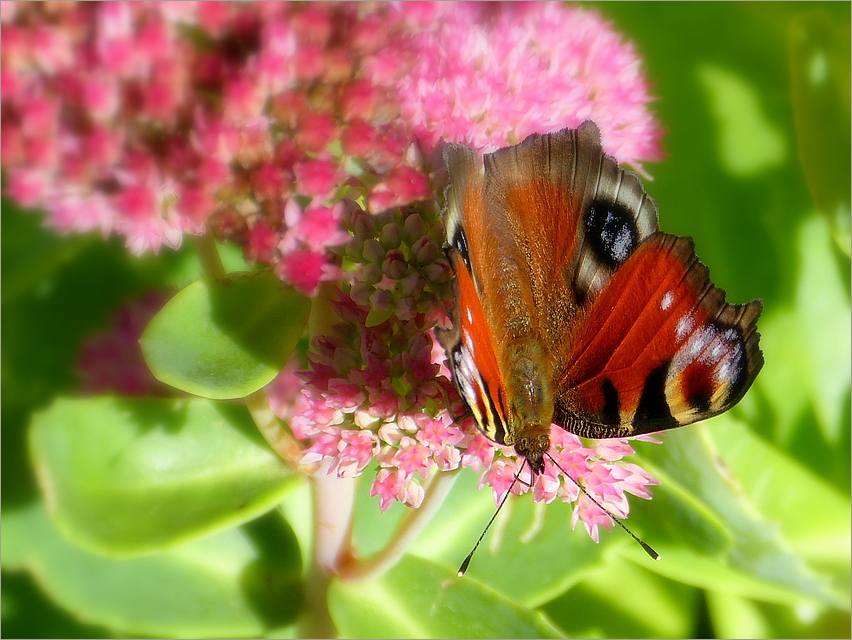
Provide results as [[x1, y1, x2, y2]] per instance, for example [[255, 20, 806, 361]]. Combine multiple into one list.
[[2, 2, 432, 293]]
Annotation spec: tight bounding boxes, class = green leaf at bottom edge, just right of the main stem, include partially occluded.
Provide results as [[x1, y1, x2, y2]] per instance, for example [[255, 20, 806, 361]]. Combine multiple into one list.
[[329, 556, 564, 638]]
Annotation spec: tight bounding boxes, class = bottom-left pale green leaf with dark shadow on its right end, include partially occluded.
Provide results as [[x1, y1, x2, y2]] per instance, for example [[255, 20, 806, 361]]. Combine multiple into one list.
[[3, 504, 301, 637]]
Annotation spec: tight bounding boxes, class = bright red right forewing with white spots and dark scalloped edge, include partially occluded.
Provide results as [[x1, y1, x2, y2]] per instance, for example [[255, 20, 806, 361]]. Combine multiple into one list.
[[554, 233, 763, 438]]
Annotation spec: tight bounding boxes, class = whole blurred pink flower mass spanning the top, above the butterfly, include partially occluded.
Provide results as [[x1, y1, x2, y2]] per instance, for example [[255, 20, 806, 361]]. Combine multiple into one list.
[[0, 2, 660, 294]]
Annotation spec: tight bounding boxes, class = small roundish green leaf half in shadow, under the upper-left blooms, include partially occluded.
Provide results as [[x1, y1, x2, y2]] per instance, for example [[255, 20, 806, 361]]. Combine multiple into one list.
[[140, 271, 310, 399]]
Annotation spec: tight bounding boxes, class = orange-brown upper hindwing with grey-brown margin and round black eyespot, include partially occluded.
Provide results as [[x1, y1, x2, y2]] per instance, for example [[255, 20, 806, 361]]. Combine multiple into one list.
[[485, 121, 657, 351]]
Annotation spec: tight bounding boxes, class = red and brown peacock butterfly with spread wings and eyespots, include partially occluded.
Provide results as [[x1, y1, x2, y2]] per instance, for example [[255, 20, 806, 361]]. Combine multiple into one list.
[[438, 121, 763, 475]]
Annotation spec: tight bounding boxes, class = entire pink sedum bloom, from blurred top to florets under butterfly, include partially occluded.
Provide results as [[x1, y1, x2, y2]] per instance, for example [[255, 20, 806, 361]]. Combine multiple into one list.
[[8, 2, 660, 537]]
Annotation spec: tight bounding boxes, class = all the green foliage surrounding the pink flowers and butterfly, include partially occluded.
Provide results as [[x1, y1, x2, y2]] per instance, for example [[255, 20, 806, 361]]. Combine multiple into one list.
[[0, 3, 852, 637]]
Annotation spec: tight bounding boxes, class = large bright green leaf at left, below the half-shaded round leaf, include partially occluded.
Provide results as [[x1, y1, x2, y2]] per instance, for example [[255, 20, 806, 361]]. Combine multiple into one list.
[[30, 398, 297, 555]]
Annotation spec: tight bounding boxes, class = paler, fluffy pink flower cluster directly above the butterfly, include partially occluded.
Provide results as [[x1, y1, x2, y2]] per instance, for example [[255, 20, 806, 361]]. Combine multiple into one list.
[[398, 2, 661, 168]]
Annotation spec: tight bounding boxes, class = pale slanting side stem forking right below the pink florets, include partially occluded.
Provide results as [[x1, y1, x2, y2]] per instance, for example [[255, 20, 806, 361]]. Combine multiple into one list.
[[339, 470, 458, 582]]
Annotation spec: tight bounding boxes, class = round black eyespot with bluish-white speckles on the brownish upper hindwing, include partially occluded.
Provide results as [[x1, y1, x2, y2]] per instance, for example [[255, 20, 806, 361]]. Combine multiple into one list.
[[586, 200, 639, 269]]
